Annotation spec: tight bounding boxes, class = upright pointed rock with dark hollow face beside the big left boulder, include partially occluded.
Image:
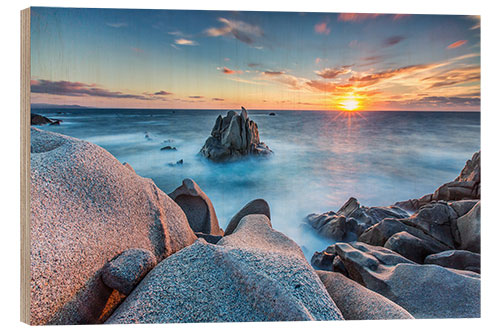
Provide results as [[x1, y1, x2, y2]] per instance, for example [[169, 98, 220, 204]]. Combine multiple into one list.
[[169, 178, 224, 235]]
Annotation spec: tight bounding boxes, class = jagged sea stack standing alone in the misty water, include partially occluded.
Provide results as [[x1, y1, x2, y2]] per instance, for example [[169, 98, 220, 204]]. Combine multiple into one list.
[[200, 107, 272, 162]]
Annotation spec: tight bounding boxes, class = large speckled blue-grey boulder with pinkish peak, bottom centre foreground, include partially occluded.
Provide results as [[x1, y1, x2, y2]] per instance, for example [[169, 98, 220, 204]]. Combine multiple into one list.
[[107, 215, 342, 324]]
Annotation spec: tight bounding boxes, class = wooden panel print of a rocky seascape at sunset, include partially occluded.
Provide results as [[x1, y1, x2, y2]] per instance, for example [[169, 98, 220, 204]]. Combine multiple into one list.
[[21, 7, 481, 325]]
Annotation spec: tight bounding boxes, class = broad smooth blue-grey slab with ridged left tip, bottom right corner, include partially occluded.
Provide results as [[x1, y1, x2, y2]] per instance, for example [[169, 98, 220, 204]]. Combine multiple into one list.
[[335, 242, 480, 318]]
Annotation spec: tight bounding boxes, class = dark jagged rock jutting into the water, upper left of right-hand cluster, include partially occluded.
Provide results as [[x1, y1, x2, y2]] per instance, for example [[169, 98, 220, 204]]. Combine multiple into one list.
[[306, 198, 410, 241]]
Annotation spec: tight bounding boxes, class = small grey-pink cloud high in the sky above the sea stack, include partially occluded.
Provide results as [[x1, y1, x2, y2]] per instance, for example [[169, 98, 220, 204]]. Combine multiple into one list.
[[205, 17, 263, 45]]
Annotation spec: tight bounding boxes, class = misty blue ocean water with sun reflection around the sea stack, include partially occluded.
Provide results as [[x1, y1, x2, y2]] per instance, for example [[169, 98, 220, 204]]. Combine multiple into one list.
[[37, 109, 480, 259]]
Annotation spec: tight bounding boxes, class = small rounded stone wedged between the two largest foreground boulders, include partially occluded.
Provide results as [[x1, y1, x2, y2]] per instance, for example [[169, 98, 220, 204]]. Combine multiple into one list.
[[101, 249, 156, 295]]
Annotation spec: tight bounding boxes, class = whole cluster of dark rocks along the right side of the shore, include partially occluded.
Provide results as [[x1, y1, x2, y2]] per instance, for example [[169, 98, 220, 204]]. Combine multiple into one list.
[[306, 152, 481, 318]]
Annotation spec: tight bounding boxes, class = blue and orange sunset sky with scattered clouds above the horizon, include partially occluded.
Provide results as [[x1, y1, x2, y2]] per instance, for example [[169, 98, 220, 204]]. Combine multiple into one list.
[[31, 7, 480, 111]]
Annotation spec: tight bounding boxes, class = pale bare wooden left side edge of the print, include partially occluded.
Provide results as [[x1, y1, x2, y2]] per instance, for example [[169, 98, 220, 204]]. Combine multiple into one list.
[[20, 8, 31, 324]]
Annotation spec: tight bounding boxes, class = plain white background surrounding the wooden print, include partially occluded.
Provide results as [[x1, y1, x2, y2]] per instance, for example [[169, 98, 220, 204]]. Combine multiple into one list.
[[0, 0, 500, 333]]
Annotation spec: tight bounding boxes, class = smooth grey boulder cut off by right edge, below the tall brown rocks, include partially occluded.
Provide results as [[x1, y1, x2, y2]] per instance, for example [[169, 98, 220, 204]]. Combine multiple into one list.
[[457, 201, 481, 253]]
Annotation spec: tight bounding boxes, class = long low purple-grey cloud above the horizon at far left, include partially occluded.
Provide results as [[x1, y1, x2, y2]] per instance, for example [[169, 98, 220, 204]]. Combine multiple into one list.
[[31, 80, 168, 100]]
